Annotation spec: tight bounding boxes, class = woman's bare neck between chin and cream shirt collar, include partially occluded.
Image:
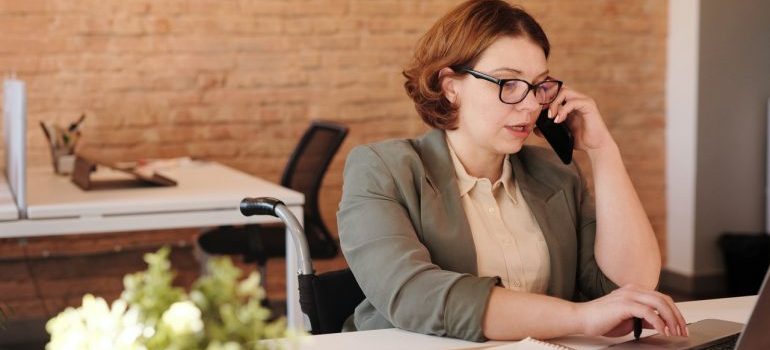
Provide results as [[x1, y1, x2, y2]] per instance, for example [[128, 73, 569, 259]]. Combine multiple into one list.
[[447, 131, 505, 182]]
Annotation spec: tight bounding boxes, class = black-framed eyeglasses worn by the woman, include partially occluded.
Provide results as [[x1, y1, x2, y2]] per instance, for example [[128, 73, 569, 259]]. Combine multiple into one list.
[[453, 67, 564, 105]]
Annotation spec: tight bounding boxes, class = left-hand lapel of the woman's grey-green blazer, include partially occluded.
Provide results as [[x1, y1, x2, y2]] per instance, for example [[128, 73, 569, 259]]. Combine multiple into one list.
[[414, 129, 478, 275]]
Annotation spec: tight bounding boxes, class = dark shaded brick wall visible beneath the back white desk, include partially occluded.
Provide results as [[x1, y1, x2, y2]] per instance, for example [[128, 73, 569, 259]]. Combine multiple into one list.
[[0, 234, 200, 322]]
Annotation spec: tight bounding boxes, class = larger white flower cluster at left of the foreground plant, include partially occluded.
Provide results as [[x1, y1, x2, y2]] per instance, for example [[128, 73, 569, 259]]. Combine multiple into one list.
[[46, 294, 145, 350]]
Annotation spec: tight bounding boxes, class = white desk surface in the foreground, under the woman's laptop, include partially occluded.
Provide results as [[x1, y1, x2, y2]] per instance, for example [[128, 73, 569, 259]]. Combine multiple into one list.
[[272, 296, 757, 350]]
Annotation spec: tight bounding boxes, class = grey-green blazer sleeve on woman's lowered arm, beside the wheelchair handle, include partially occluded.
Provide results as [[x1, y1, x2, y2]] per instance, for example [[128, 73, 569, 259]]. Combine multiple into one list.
[[337, 146, 498, 341]]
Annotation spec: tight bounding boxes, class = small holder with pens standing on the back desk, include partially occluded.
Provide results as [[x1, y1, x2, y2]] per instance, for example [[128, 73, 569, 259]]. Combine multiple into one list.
[[40, 114, 86, 175]]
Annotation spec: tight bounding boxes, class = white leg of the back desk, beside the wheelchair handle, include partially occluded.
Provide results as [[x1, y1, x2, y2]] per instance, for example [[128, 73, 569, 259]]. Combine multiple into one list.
[[286, 205, 310, 330]]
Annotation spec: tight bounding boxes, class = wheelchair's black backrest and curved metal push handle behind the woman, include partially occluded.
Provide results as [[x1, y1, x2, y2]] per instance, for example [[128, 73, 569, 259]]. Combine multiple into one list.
[[240, 197, 364, 334]]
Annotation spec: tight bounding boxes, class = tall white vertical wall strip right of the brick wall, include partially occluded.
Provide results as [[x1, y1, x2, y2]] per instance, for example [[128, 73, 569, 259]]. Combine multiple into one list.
[[666, 0, 700, 276]]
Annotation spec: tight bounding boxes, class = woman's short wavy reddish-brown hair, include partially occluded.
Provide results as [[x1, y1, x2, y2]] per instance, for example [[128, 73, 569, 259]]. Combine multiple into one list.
[[403, 0, 551, 130]]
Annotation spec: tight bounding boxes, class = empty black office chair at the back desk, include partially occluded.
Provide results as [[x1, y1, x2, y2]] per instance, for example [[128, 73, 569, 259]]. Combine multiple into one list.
[[198, 121, 348, 294]]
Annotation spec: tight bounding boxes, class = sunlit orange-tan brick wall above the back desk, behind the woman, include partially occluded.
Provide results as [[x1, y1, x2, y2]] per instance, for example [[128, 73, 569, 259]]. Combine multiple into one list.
[[0, 0, 667, 320]]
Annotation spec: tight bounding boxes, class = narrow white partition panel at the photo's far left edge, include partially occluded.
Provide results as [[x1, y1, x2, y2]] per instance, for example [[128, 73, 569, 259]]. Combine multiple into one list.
[[3, 78, 27, 218]]
